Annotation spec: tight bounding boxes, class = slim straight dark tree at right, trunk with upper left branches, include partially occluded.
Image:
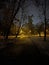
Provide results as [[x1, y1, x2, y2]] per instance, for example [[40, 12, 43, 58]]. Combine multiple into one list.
[[35, 0, 46, 41]]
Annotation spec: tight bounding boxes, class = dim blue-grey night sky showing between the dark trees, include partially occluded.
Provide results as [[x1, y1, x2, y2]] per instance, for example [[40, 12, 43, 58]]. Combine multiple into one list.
[[0, 0, 49, 24]]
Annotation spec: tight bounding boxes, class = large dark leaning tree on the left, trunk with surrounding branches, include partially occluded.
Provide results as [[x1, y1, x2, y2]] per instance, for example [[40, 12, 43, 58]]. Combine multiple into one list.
[[2, 0, 22, 39]]
